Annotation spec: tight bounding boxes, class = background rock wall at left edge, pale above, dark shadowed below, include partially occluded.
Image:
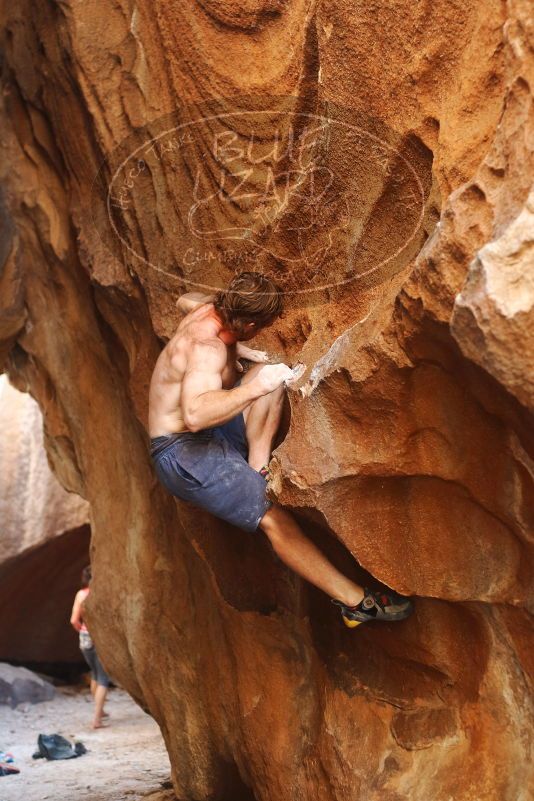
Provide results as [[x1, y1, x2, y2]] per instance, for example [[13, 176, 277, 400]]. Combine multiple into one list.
[[0, 376, 90, 666]]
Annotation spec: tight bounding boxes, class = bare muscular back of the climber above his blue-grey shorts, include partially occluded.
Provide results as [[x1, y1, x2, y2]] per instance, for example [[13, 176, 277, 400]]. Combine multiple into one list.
[[148, 303, 237, 437]]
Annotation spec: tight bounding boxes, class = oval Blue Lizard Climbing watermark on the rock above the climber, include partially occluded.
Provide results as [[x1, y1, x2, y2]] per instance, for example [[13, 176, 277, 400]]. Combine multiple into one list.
[[92, 96, 438, 303]]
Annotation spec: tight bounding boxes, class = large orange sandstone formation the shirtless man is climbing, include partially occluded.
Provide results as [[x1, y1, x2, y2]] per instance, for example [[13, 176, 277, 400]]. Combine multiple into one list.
[[0, 0, 534, 801]]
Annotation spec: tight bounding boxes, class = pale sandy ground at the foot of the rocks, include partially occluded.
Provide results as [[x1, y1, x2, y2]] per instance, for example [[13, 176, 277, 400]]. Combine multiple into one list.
[[0, 687, 170, 801]]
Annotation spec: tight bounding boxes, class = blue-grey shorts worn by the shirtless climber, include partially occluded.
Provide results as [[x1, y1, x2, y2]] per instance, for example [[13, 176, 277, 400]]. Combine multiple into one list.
[[150, 413, 272, 532]]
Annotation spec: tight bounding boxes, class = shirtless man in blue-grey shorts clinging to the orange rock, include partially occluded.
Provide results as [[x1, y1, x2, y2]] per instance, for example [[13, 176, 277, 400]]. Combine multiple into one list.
[[149, 272, 412, 628]]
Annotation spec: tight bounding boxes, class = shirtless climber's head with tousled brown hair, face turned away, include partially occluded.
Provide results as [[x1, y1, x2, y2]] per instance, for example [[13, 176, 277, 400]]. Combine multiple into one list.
[[213, 272, 282, 341]]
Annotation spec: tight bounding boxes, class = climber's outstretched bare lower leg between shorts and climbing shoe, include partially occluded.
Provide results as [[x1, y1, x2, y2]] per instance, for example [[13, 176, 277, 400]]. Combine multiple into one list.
[[260, 504, 363, 606]]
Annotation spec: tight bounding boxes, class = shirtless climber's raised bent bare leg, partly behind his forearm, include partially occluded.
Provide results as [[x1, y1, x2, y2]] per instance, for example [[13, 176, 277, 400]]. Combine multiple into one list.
[[241, 364, 285, 470]]
